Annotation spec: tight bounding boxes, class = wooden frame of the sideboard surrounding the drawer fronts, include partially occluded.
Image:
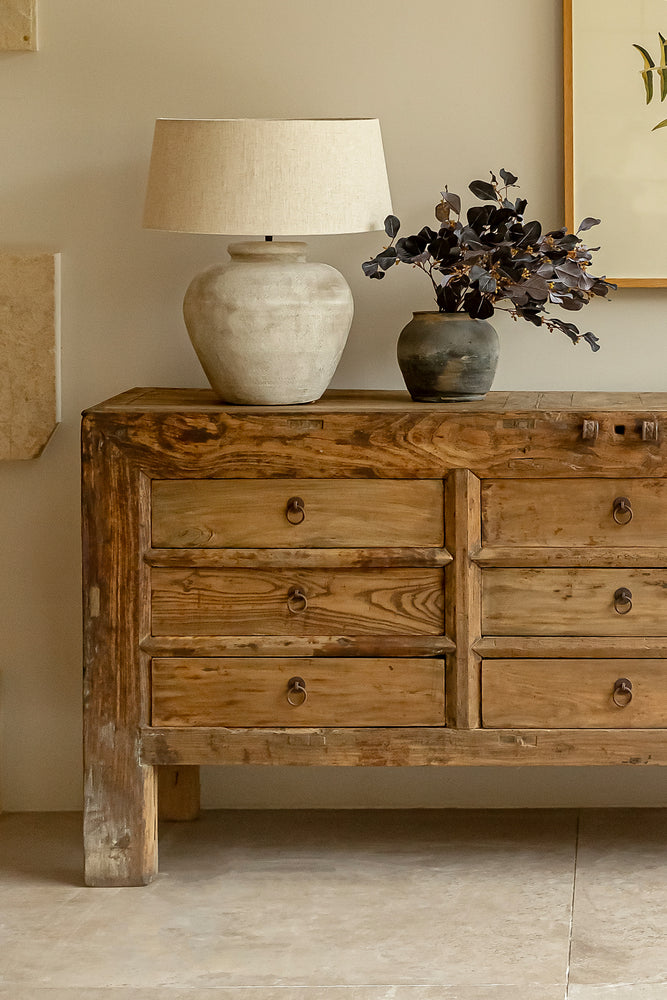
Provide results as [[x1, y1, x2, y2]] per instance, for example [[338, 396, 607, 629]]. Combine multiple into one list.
[[82, 389, 667, 886]]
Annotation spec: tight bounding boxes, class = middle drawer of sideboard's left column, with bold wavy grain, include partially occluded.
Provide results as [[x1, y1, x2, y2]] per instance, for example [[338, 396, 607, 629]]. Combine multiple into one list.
[[151, 569, 444, 636]]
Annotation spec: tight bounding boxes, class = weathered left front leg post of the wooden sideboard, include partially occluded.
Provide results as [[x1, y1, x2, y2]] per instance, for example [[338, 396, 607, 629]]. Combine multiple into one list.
[[82, 417, 157, 886]]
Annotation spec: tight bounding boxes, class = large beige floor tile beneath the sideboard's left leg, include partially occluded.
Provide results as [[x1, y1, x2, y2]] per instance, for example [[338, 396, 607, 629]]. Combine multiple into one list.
[[0, 811, 576, 1000]]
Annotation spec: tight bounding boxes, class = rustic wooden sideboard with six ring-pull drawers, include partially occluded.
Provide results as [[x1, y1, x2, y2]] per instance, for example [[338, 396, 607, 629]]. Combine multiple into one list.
[[82, 389, 667, 885]]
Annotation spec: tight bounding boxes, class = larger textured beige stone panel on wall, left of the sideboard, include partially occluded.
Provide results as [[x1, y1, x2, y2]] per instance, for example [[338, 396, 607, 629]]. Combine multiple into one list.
[[0, 253, 60, 460]]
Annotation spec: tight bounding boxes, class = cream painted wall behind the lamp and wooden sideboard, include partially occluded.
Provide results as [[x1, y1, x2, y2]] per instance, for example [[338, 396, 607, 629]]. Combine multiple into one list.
[[0, 0, 667, 810]]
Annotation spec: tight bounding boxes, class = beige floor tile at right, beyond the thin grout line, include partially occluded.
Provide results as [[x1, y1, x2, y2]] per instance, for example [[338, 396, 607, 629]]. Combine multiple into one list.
[[570, 809, 667, 988]]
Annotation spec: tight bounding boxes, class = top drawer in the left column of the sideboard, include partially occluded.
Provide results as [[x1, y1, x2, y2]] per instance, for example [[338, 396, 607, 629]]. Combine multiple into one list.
[[152, 478, 444, 548]]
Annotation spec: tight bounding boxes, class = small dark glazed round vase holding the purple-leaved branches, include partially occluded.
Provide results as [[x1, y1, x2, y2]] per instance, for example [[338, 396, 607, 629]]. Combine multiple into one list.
[[397, 312, 500, 403]]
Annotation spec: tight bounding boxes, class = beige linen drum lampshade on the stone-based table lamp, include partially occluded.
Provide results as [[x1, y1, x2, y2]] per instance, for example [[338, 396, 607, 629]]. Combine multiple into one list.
[[144, 118, 391, 236]]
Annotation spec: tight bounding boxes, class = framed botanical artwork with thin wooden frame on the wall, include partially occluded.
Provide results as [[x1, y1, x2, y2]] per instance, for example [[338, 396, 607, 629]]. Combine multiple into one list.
[[563, 0, 667, 288]]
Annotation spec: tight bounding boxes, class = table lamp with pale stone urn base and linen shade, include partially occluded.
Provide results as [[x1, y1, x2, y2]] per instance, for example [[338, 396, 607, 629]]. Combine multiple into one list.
[[144, 118, 391, 404]]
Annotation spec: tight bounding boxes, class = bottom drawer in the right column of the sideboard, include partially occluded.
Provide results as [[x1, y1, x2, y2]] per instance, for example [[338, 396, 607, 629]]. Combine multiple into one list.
[[482, 660, 667, 729]]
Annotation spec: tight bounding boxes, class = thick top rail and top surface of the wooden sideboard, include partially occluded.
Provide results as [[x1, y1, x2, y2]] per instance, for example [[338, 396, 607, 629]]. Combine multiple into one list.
[[82, 390, 667, 479]]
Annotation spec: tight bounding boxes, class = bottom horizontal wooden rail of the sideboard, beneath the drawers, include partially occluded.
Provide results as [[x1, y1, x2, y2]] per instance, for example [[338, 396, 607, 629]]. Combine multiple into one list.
[[142, 727, 667, 767]]
